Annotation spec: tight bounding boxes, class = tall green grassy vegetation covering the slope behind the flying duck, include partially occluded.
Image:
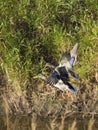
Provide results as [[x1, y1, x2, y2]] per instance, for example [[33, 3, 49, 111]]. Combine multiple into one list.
[[0, 0, 98, 115]]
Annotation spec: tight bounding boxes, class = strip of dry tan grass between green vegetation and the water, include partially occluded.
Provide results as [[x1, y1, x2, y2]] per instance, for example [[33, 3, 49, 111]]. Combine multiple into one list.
[[0, 78, 98, 117]]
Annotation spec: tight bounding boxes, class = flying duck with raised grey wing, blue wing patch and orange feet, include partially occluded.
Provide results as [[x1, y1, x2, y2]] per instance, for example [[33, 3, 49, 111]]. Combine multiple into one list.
[[34, 43, 78, 99]]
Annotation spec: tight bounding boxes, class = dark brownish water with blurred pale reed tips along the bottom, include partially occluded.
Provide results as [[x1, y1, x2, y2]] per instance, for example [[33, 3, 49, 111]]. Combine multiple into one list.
[[0, 113, 98, 130]]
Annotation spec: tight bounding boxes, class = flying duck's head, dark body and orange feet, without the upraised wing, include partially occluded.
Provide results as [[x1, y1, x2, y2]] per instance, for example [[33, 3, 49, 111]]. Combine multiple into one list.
[[38, 66, 78, 99]]
